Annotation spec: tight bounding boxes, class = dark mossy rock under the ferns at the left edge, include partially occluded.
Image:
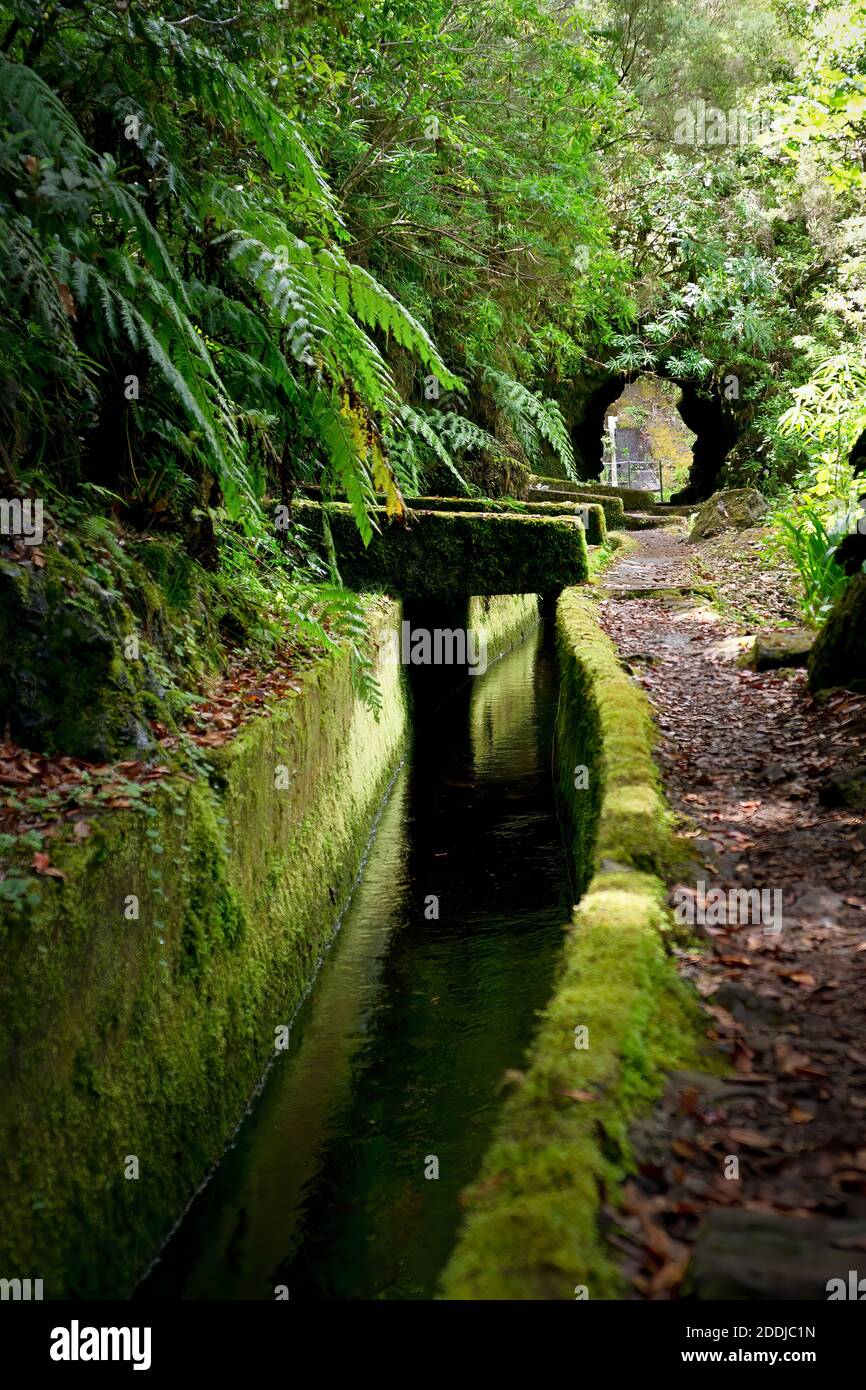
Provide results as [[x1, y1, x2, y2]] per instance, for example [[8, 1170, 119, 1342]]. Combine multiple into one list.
[[0, 530, 234, 762]]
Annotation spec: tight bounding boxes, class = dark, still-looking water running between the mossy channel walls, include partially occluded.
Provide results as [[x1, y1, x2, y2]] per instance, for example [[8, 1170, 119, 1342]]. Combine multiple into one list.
[[136, 614, 571, 1300]]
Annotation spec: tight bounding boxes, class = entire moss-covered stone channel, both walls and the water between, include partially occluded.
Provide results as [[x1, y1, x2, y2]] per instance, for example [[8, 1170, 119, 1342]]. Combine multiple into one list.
[[0, 569, 702, 1300]]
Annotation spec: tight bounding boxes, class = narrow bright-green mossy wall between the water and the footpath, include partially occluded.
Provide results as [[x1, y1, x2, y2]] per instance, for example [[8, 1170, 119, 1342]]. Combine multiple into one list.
[[442, 589, 703, 1300]]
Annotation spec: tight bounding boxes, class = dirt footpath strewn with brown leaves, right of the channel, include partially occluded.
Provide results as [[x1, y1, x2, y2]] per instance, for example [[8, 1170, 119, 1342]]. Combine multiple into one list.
[[602, 531, 866, 1298]]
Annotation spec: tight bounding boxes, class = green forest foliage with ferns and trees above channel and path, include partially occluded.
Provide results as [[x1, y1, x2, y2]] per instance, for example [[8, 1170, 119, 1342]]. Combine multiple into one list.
[[0, 0, 866, 667]]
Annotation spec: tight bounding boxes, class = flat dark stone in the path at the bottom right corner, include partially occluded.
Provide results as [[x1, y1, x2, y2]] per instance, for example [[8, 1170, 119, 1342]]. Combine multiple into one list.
[[684, 1208, 866, 1301]]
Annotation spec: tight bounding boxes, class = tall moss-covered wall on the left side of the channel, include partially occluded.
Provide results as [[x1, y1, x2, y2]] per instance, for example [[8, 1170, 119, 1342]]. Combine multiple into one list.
[[0, 599, 406, 1298]]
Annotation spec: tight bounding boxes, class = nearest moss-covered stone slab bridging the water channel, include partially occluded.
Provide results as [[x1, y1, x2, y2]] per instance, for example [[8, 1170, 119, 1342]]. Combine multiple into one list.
[[295, 502, 588, 602]]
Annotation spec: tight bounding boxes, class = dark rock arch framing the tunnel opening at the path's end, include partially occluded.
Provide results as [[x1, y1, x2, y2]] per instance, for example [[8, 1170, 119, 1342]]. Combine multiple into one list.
[[571, 373, 740, 502]]
